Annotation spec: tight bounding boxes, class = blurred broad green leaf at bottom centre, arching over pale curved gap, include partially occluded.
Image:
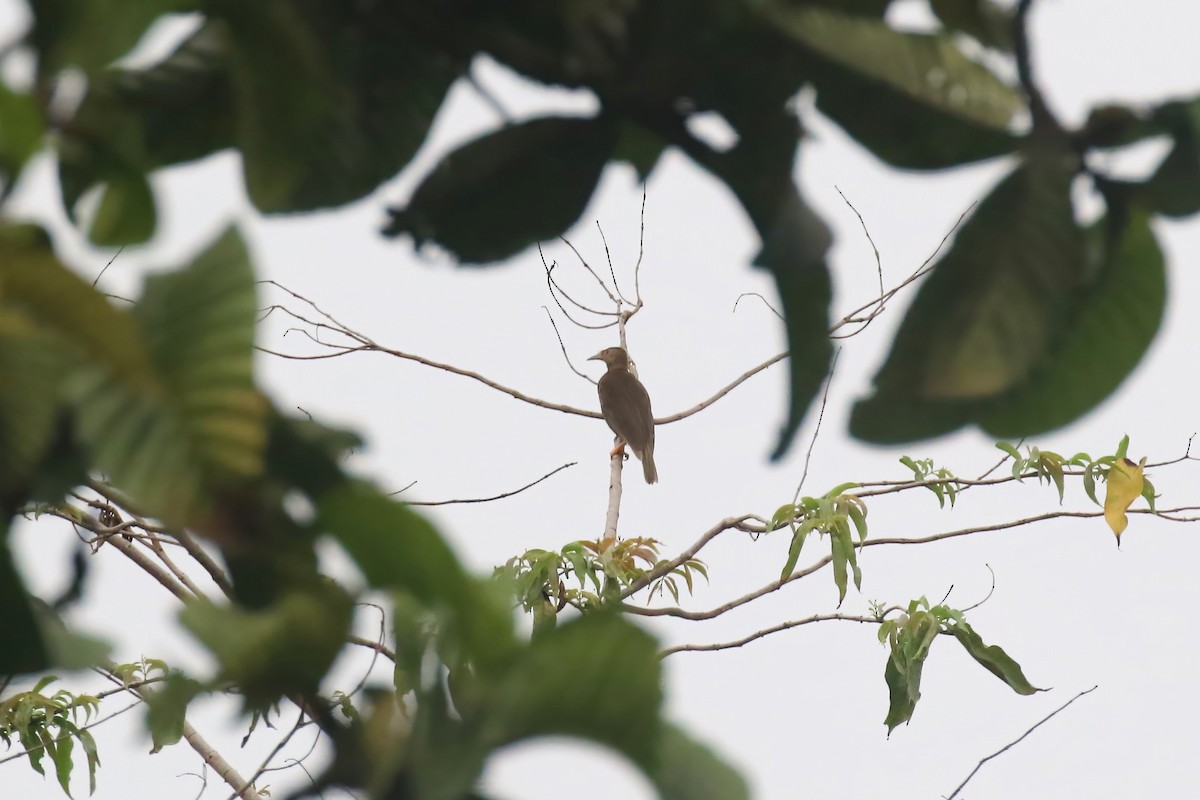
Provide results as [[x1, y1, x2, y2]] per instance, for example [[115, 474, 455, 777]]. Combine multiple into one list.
[[481, 613, 662, 770]]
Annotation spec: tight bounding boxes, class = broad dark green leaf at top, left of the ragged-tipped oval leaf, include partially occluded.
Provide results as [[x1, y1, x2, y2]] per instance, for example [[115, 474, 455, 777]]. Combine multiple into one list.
[[216, 0, 466, 212]]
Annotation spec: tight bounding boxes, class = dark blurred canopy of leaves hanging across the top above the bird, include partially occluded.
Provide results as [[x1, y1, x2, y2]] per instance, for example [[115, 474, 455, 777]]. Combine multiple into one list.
[[0, 0, 1185, 456]]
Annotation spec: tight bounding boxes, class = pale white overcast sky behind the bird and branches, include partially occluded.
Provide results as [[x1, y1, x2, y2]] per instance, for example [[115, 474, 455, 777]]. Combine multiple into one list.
[[0, 0, 1200, 800]]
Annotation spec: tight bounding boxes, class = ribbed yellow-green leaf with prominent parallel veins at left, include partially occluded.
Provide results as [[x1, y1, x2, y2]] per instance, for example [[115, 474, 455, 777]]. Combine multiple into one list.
[[71, 225, 266, 521]]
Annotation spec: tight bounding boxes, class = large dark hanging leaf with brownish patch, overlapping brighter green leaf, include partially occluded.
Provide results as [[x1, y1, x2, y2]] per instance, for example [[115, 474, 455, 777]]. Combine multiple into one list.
[[851, 150, 1087, 441]]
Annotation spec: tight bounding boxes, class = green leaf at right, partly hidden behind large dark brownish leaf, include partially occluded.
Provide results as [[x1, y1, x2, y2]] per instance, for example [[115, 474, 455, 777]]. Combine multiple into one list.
[[980, 212, 1166, 437]]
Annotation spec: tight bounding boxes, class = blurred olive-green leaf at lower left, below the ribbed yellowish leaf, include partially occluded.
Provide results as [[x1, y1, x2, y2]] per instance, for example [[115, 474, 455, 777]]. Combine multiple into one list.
[[180, 581, 354, 710]]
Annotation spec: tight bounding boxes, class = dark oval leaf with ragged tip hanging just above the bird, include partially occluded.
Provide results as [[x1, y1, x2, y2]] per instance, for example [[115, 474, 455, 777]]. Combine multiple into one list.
[[384, 116, 617, 264]]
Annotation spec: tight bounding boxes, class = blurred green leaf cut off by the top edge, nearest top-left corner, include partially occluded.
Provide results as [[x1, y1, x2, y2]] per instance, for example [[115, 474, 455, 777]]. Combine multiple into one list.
[[29, 0, 187, 77]]
